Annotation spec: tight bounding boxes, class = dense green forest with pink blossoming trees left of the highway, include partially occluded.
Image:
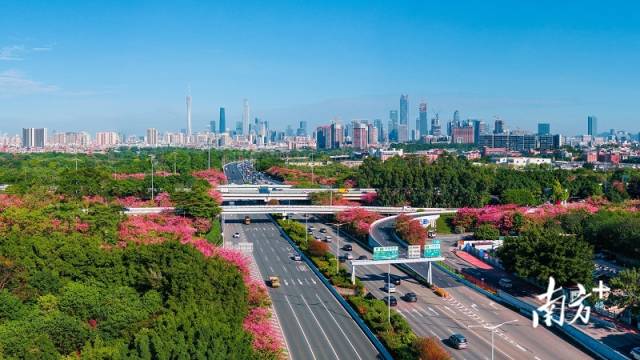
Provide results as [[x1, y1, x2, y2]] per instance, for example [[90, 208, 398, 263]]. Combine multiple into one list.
[[0, 150, 278, 359]]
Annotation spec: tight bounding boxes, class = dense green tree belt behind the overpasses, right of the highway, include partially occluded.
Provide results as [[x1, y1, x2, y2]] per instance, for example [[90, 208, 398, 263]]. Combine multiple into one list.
[[355, 156, 640, 207]]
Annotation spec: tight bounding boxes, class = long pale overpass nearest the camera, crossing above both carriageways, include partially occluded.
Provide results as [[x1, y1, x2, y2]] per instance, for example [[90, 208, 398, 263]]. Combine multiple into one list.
[[124, 205, 457, 215]]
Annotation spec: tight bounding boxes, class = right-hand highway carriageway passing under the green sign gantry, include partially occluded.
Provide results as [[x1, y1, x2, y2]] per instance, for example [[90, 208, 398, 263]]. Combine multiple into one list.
[[298, 217, 591, 360]]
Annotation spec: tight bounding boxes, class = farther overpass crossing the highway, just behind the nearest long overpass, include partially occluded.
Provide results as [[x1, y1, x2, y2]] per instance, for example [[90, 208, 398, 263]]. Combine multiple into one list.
[[218, 184, 376, 202]]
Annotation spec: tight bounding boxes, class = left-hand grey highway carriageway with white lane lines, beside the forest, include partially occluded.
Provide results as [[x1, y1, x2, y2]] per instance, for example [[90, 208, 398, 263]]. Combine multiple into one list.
[[224, 215, 379, 360]]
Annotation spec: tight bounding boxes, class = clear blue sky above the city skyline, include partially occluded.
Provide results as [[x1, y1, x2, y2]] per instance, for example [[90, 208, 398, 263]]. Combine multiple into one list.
[[0, 0, 640, 134]]
